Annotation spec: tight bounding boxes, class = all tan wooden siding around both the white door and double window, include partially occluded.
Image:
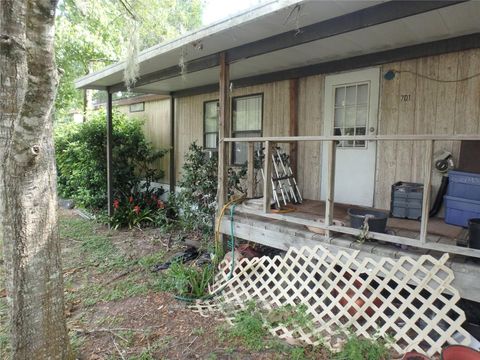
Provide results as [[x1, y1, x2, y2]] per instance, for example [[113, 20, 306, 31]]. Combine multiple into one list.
[[176, 49, 480, 209]]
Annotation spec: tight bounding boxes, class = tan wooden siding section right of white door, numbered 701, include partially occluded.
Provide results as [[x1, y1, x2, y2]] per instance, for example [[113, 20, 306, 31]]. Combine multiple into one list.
[[375, 49, 480, 209]]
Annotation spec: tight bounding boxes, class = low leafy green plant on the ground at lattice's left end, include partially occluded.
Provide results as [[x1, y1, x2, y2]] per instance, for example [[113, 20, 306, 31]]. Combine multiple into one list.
[[160, 262, 215, 298]]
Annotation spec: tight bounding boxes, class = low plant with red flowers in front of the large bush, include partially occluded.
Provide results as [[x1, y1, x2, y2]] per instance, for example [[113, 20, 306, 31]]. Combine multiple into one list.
[[110, 182, 165, 229]]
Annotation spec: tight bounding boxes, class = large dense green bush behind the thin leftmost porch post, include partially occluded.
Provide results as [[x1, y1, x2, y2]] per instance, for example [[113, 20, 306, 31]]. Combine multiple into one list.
[[55, 110, 168, 209]]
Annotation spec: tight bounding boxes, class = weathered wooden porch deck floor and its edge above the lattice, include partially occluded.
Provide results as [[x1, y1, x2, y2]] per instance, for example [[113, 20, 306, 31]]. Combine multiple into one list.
[[221, 200, 480, 301]]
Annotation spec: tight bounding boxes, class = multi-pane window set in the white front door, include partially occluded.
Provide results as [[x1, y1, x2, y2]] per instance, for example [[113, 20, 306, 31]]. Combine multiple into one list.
[[334, 83, 369, 148]]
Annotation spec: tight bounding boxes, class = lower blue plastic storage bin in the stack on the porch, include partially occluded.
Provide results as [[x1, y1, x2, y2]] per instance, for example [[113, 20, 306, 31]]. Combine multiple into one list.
[[444, 196, 480, 227]]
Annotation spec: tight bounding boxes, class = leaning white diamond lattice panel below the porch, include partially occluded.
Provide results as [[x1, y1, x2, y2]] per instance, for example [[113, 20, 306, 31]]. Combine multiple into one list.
[[193, 246, 469, 356]]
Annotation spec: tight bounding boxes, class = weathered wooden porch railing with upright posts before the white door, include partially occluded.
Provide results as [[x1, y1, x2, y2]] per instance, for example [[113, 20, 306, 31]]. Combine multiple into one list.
[[220, 135, 480, 258]]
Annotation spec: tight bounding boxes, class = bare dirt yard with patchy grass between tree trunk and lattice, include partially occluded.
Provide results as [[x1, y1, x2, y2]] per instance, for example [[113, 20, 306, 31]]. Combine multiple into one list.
[[60, 209, 325, 360]]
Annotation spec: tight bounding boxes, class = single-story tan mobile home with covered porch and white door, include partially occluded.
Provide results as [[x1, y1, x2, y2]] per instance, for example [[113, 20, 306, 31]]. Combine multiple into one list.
[[76, 0, 480, 301]]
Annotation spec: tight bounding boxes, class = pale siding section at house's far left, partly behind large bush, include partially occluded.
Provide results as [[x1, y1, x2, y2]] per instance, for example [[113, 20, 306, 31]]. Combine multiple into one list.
[[117, 99, 170, 184]]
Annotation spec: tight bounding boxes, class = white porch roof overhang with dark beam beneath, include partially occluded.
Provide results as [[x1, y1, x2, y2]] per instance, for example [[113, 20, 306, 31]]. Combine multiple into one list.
[[76, 0, 480, 94]]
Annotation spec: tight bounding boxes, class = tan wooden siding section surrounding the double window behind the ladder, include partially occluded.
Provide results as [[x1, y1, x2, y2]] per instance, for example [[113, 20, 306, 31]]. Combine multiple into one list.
[[175, 81, 290, 179]]
